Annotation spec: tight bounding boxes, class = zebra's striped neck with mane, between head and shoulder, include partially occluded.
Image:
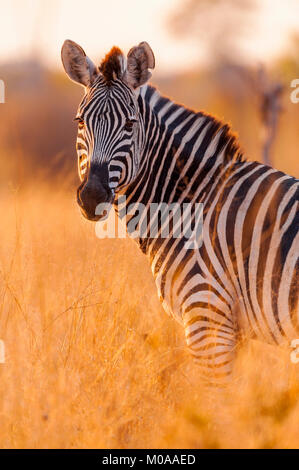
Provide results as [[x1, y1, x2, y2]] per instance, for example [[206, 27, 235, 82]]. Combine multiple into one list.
[[119, 86, 242, 252]]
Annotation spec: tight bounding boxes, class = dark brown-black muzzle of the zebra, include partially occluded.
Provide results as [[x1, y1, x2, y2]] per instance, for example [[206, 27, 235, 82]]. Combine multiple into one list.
[[77, 164, 112, 220]]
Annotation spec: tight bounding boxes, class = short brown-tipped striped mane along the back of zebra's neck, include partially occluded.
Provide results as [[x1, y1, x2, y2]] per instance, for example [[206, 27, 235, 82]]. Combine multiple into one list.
[[143, 85, 246, 162]]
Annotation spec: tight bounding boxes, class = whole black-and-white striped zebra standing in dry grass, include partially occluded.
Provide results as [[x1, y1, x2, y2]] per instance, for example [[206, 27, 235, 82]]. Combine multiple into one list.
[[61, 40, 299, 383]]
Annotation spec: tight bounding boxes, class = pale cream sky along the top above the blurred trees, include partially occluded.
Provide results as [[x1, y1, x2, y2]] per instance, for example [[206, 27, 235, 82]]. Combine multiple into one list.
[[0, 0, 299, 73]]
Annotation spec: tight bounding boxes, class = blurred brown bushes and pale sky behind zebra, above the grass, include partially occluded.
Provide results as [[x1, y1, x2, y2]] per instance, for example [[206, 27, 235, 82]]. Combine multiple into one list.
[[0, 0, 299, 182]]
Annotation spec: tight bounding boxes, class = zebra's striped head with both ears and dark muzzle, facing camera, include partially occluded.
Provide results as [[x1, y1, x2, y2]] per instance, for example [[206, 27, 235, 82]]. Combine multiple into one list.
[[61, 40, 155, 220]]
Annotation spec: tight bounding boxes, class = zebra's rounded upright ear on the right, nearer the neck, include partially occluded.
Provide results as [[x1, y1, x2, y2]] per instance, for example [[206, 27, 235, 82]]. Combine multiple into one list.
[[124, 41, 155, 89]]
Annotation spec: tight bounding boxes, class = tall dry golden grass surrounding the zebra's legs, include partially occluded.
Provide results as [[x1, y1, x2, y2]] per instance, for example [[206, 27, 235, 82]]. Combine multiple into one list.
[[0, 185, 299, 448]]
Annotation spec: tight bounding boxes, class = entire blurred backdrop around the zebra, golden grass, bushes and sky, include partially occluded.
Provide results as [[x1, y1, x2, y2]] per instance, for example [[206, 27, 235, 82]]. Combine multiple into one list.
[[0, 0, 299, 448]]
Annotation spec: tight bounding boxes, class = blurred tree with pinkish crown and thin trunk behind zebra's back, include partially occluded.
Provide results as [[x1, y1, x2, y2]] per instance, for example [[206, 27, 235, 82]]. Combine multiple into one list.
[[169, 0, 283, 165]]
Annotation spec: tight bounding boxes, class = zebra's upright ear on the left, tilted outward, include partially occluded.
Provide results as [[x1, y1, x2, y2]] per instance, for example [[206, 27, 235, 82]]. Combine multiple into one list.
[[61, 39, 99, 87]]
